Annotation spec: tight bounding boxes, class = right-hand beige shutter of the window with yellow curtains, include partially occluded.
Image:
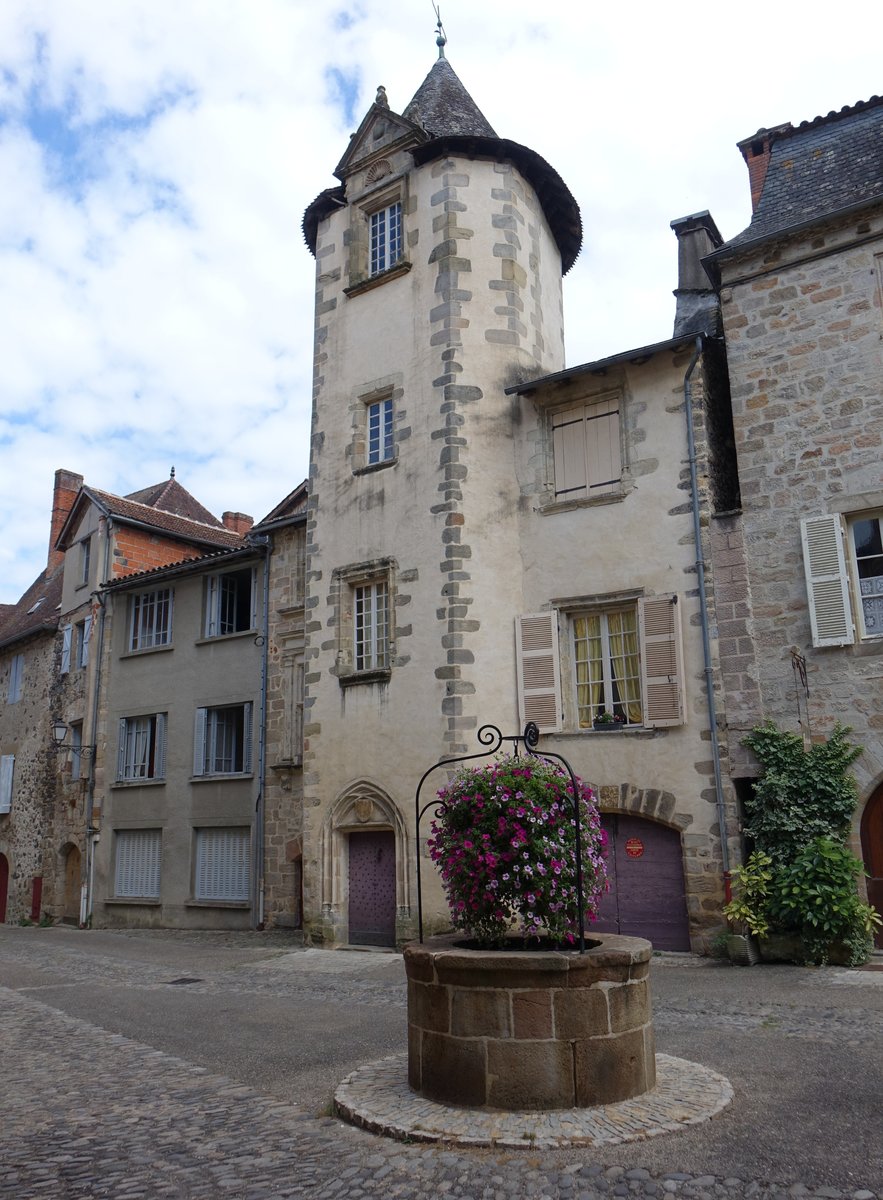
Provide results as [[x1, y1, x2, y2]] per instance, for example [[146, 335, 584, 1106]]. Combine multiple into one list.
[[638, 594, 686, 727]]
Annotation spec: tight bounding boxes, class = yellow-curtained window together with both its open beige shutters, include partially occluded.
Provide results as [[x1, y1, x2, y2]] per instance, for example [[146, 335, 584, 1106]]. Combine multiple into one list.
[[516, 595, 686, 733]]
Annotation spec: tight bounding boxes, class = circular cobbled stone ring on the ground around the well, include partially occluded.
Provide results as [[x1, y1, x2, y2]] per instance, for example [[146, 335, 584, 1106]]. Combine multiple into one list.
[[335, 1054, 733, 1150]]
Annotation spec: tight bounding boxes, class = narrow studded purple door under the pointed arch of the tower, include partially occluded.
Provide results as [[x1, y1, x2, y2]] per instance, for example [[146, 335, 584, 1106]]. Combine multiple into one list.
[[349, 829, 396, 946]]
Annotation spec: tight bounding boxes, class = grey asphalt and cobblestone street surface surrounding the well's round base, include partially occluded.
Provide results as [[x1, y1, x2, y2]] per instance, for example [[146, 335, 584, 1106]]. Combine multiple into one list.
[[0, 926, 883, 1200]]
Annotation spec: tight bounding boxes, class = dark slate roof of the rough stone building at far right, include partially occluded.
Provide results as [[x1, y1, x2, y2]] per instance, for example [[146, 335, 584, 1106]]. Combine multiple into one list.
[[709, 96, 883, 259]]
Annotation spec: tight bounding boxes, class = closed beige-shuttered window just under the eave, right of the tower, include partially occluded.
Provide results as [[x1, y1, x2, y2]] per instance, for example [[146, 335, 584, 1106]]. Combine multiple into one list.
[[551, 395, 623, 500]]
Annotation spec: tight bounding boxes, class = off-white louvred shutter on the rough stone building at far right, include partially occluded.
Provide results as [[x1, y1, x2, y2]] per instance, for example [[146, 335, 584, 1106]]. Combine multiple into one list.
[[800, 512, 855, 646]]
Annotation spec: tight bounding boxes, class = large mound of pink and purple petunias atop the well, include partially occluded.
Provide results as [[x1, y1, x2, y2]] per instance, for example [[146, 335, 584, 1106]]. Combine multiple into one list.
[[427, 757, 608, 946]]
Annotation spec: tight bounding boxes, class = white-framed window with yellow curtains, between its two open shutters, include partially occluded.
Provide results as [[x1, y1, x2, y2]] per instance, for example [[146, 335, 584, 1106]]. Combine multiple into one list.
[[572, 606, 643, 728]]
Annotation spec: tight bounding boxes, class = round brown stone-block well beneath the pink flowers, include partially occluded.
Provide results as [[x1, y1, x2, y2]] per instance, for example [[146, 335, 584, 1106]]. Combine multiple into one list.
[[404, 934, 656, 1110]]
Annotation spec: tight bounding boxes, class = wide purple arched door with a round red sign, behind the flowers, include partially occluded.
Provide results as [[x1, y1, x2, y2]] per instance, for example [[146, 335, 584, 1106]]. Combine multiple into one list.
[[589, 814, 690, 950]]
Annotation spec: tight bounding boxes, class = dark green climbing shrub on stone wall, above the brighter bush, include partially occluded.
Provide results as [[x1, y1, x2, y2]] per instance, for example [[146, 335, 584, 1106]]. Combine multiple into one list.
[[744, 721, 861, 864]]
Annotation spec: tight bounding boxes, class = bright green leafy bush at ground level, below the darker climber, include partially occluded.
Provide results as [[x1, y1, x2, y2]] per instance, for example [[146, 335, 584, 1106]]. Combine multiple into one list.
[[769, 838, 881, 966]]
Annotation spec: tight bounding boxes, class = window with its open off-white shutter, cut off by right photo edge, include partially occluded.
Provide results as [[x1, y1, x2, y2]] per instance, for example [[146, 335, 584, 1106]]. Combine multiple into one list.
[[800, 512, 883, 646]]
